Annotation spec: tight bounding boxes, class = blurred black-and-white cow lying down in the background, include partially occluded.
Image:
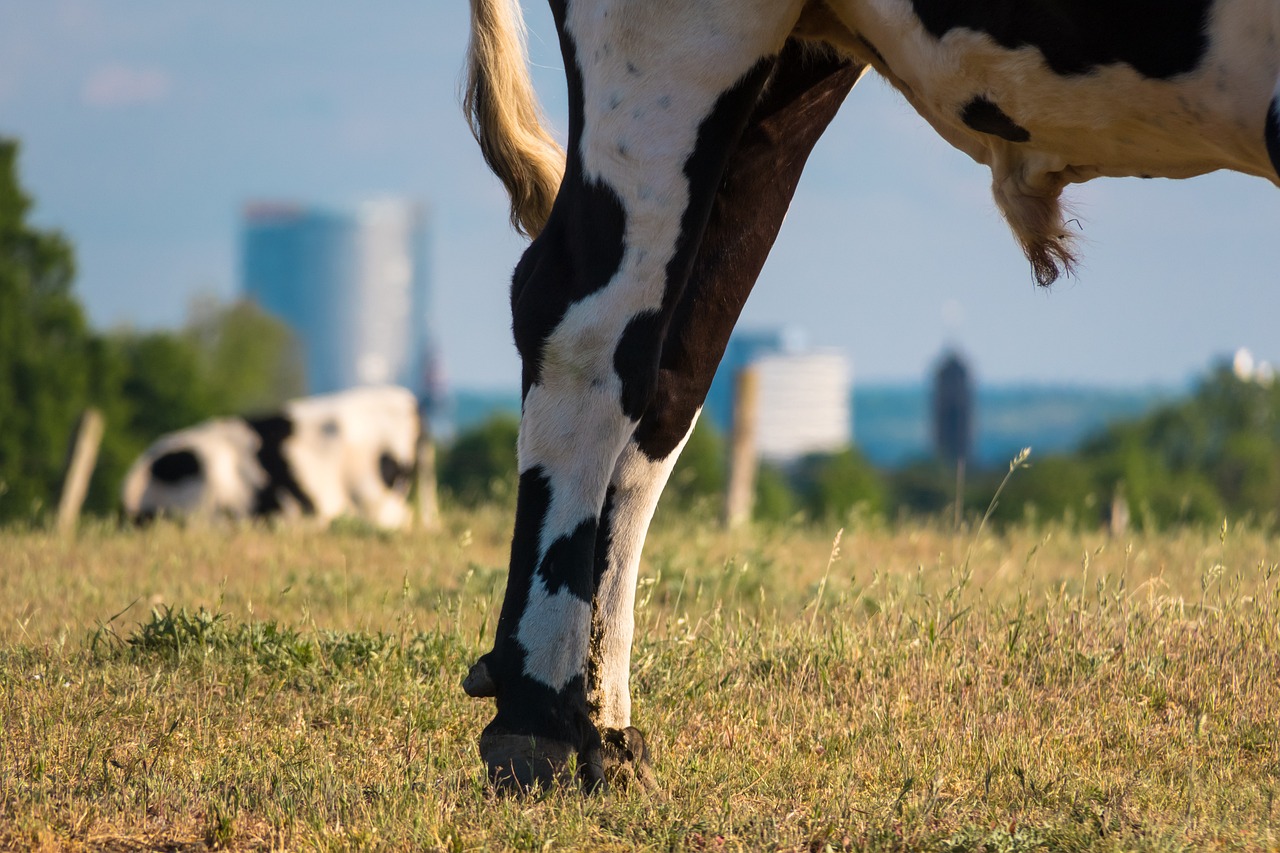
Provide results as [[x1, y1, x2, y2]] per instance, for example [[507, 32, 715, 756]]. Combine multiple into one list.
[[123, 387, 421, 529]]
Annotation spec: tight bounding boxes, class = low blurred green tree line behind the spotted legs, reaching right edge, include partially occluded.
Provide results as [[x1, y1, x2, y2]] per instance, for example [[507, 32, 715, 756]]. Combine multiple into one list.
[[440, 365, 1280, 529]]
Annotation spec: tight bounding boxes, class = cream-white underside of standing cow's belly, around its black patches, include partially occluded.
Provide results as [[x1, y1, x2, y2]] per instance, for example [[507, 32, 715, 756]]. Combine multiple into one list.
[[831, 0, 1280, 183]]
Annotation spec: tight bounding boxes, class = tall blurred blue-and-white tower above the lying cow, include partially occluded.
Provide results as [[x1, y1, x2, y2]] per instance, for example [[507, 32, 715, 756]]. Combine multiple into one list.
[[241, 199, 443, 407]]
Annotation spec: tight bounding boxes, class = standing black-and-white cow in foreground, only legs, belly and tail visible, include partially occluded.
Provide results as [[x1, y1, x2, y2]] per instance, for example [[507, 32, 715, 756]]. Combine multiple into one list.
[[463, 0, 1280, 789]]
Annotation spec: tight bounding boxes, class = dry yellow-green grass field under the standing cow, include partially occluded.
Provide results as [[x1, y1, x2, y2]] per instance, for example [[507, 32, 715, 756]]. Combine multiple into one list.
[[0, 510, 1280, 852]]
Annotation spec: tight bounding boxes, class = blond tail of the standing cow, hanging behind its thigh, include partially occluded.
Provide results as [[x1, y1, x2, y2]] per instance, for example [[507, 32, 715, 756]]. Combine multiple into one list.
[[462, 0, 564, 237]]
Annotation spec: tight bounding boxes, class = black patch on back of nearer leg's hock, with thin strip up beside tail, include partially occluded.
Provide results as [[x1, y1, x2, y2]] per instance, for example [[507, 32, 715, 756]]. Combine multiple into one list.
[[511, 0, 627, 393]]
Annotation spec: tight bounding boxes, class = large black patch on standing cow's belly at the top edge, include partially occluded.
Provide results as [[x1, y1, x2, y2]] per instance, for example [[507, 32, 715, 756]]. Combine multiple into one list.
[[911, 0, 1213, 79]]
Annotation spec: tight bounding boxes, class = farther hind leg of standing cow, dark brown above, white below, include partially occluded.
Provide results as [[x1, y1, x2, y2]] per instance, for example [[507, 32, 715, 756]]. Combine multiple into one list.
[[588, 41, 863, 786]]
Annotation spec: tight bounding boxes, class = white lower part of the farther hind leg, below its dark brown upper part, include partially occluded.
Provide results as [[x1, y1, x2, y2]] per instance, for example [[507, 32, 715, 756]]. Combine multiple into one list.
[[589, 410, 701, 729]]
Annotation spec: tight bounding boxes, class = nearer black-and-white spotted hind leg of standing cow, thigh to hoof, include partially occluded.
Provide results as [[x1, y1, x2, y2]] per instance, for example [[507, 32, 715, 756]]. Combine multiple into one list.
[[467, 0, 795, 790]]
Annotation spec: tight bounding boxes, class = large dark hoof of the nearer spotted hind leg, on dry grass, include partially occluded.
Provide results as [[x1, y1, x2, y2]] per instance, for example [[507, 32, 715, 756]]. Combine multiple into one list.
[[480, 731, 604, 794]]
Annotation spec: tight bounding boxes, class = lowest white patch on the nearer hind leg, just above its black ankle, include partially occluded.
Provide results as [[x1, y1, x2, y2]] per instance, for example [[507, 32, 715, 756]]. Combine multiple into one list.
[[516, 573, 591, 690]]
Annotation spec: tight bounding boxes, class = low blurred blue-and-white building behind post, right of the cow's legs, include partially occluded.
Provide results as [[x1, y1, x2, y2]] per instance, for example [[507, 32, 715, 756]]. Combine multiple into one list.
[[704, 329, 852, 462]]
